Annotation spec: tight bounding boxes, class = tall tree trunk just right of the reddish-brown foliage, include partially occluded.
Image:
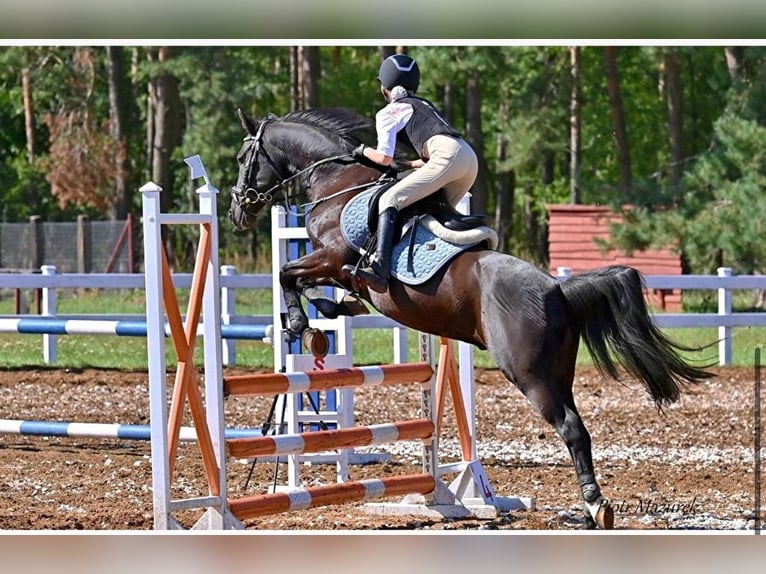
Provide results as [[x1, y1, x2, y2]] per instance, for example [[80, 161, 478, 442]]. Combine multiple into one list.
[[106, 46, 129, 219]]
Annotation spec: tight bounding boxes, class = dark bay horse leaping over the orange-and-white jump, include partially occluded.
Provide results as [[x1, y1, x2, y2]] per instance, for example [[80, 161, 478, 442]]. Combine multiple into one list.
[[229, 108, 712, 529]]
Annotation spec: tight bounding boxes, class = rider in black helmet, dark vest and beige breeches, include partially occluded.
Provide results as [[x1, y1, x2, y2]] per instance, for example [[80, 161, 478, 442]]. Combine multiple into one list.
[[346, 54, 478, 293]]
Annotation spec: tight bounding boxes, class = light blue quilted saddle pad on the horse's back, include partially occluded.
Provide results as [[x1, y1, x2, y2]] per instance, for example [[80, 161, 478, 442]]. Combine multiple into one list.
[[340, 188, 477, 285]]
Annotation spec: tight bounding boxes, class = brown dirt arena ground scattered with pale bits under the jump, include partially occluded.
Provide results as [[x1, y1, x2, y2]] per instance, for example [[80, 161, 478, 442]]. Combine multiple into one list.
[[0, 368, 764, 531]]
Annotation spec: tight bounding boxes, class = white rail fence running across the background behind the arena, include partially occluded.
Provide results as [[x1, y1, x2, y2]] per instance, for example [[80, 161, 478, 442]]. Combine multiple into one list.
[[0, 265, 766, 365]]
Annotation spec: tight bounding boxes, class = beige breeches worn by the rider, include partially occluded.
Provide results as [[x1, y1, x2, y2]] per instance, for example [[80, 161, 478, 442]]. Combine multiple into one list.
[[379, 135, 479, 213]]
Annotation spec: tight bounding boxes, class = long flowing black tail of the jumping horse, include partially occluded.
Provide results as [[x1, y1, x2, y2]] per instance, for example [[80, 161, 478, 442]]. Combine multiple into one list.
[[561, 265, 712, 408]]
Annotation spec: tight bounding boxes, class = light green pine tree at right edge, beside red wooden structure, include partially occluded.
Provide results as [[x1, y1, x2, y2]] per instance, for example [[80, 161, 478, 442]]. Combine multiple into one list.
[[615, 114, 766, 274]]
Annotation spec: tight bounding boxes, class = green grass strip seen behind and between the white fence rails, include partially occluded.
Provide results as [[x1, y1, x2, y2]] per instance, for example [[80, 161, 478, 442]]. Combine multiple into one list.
[[0, 289, 766, 369]]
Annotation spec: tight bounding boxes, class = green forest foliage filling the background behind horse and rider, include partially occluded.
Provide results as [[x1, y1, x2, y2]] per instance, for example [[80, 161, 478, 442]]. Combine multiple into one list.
[[0, 45, 766, 272]]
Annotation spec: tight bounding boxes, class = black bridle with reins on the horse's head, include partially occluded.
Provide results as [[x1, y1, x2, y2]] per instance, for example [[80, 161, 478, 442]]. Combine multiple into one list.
[[231, 118, 360, 215]]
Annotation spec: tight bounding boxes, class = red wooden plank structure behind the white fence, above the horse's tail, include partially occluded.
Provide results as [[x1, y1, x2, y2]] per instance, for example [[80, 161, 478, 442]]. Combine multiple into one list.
[[548, 205, 683, 312]]
